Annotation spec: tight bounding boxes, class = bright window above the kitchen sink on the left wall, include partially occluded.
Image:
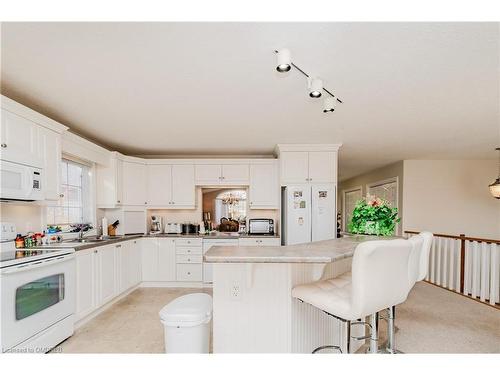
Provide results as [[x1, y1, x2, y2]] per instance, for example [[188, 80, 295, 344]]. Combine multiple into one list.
[[47, 159, 91, 225]]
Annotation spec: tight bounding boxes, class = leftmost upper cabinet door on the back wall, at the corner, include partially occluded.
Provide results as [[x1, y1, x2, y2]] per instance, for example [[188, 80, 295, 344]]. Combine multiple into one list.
[[121, 160, 147, 206]]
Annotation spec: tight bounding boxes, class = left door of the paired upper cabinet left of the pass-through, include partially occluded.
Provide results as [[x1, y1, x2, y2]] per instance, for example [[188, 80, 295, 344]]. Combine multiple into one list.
[[147, 164, 172, 207]]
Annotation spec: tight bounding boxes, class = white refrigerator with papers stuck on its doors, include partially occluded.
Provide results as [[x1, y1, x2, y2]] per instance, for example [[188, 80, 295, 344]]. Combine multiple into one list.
[[281, 184, 337, 245]]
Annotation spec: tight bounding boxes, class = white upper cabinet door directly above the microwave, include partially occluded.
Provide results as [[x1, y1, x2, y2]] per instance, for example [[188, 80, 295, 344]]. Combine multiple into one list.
[[0, 109, 44, 168]]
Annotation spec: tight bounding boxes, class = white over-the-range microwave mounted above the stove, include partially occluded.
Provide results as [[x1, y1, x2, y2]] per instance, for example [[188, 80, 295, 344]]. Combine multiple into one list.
[[0, 160, 44, 201]]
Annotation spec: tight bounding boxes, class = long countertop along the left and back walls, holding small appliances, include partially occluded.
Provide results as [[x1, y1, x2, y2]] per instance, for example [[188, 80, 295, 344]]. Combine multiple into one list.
[[31, 233, 279, 251]]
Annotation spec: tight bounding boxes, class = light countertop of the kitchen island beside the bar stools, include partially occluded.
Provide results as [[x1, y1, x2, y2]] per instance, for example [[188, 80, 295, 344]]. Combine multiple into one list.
[[203, 235, 395, 263]]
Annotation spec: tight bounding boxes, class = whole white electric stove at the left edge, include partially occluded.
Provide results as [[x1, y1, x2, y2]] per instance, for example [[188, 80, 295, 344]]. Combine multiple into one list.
[[0, 231, 76, 353]]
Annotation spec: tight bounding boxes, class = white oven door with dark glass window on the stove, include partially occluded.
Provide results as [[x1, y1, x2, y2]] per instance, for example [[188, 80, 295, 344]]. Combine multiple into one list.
[[0, 254, 76, 351]]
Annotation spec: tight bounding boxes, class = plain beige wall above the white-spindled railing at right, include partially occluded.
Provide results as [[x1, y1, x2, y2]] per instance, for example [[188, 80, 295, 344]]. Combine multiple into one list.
[[403, 160, 500, 239]]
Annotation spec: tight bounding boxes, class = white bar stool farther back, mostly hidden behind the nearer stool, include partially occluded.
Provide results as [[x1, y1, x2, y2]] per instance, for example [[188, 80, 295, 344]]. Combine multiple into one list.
[[385, 232, 433, 354]]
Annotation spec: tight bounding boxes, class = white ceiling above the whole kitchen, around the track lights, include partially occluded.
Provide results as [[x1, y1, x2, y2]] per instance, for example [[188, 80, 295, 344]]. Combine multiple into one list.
[[1, 23, 500, 179]]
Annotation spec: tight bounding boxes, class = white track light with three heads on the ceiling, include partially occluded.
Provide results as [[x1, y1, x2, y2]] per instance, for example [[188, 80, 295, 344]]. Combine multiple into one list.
[[274, 48, 342, 113]]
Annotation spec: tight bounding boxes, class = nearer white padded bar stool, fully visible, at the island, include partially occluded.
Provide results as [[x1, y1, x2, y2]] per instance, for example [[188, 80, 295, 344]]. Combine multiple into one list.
[[292, 239, 412, 353]]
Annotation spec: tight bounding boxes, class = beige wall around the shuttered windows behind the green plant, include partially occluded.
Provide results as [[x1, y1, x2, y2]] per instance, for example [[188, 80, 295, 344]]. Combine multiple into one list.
[[338, 161, 404, 233]]
